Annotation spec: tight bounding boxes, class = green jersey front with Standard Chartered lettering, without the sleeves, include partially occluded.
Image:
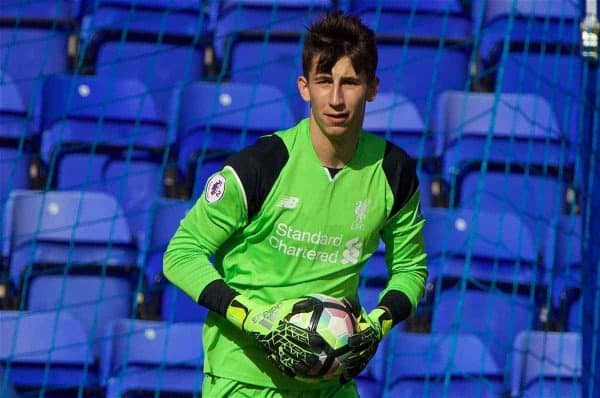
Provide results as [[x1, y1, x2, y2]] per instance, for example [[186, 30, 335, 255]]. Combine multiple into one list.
[[223, 121, 392, 301]]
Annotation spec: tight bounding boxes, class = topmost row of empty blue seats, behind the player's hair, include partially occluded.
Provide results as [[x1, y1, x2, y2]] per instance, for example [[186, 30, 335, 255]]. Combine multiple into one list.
[[2, 0, 582, 124]]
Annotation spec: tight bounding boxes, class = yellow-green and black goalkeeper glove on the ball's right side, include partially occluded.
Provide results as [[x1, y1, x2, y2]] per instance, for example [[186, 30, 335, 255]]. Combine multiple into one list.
[[340, 299, 392, 383]]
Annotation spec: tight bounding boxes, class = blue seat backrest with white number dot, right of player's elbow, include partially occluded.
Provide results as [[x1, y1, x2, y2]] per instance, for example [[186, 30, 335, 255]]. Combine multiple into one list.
[[423, 208, 550, 285]]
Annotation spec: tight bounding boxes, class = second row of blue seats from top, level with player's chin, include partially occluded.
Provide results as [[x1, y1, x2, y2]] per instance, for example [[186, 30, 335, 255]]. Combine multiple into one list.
[[0, 71, 576, 215]]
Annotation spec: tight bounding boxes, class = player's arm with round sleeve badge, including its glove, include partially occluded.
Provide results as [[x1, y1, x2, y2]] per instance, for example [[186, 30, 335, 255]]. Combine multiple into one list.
[[163, 139, 316, 375]]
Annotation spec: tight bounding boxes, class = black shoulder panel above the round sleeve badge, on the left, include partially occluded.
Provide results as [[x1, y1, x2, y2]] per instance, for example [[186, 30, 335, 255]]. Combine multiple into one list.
[[225, 135, 290, 220]]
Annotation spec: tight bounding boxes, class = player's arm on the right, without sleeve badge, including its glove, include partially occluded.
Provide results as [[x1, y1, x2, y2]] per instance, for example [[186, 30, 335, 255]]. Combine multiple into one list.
[[344, 147, 427, 379]]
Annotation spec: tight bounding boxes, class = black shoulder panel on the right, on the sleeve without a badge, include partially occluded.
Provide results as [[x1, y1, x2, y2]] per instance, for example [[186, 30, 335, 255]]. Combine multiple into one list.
[[382, 141, 419, 218]]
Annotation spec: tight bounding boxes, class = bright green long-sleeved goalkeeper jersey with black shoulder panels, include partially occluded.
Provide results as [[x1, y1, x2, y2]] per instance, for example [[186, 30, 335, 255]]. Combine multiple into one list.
[[164, 119, 427, 390]]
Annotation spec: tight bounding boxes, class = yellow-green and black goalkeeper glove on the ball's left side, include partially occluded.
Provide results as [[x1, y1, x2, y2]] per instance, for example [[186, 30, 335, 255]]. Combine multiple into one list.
[[226, 295, 325, 377]]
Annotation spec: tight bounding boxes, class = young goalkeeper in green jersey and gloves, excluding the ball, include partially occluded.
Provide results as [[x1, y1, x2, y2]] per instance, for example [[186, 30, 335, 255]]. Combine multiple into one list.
[[164, 13, 427, 398]]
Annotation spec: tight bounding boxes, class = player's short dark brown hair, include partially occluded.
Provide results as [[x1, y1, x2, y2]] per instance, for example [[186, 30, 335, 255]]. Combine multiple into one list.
[[302, 11, 377, 80]]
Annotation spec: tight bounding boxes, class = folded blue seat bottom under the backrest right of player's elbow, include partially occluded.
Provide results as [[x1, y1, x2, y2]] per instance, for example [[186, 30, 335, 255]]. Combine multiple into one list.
[[432, 288, 537, 372]]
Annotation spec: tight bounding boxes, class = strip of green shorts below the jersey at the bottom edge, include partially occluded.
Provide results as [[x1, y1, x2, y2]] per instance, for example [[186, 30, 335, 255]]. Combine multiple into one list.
[[202, 375, 358, 398]]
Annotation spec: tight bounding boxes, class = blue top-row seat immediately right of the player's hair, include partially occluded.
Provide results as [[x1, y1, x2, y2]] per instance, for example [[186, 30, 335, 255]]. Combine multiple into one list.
[[348, 0, 472, 117]]
